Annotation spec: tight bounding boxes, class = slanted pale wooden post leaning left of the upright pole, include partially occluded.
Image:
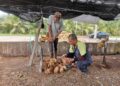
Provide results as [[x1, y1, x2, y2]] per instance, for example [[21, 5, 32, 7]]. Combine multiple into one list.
[[28, 27, 41, 66]]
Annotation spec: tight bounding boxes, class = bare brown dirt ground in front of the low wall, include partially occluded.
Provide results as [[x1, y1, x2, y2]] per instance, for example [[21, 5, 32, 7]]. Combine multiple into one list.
[[0, 55, 120, 86]]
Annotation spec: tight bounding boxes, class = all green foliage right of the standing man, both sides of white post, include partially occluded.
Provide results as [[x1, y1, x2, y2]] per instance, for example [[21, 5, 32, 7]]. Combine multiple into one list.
[[64, 20, 120, 36]]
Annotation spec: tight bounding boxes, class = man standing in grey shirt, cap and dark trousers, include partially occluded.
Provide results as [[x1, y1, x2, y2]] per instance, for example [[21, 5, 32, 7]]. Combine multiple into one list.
[[48, 12, 63, 58]]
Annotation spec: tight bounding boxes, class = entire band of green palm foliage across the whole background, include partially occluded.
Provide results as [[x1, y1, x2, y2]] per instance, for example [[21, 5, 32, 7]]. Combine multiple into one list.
[[0, 15, 120, 36]]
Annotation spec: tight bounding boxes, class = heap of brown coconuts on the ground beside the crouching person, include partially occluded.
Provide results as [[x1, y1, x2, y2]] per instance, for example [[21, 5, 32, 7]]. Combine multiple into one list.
[[43, 58, 72, 74]]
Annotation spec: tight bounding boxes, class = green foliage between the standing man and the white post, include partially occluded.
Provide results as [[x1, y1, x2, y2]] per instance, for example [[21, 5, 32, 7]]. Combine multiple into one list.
[[64, 20, 94, 35]]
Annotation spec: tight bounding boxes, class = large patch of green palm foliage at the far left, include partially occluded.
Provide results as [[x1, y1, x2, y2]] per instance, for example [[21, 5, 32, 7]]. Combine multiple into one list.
[[0, 15, 37, 34]]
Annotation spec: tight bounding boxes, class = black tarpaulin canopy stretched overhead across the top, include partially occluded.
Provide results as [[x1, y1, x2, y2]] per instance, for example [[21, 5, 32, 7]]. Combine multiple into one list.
[[0, 0, 120, 21]]
